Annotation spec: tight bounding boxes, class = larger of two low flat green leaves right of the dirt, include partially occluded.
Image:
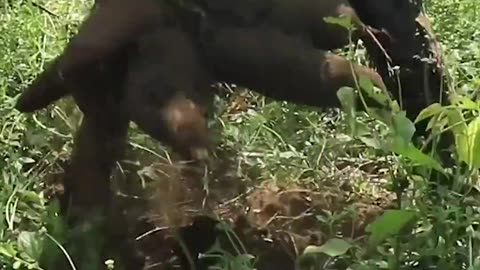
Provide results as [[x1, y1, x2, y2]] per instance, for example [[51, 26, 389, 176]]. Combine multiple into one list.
[[366, 210, 416, 247]]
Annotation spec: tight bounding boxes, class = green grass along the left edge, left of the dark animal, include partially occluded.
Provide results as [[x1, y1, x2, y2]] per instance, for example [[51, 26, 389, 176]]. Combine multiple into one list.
[[0, 1, 91, 269]]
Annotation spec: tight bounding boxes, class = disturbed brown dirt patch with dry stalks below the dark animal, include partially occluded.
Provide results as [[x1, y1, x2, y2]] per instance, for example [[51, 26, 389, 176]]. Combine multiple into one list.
[[100, 150, 393, 270]]
